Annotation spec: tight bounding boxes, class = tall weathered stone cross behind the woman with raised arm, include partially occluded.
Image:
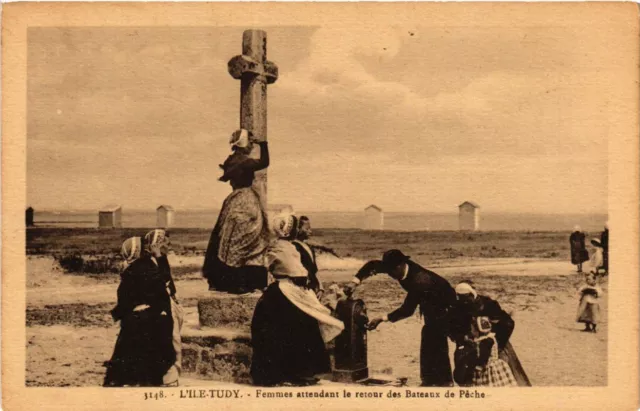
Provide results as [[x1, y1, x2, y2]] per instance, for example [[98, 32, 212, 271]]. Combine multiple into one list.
[[228, 30, 278, 209]]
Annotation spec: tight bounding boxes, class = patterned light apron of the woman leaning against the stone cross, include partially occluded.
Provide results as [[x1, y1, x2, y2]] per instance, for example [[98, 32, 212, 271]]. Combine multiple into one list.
[[214, 187, 269, 267]]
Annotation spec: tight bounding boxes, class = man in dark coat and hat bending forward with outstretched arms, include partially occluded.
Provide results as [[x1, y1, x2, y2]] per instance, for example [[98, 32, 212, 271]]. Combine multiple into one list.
[[345, 250, 456, 387]]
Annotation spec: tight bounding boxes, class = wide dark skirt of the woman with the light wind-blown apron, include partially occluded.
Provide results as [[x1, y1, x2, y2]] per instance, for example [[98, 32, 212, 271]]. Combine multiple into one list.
[[251, 282, 331, 386]]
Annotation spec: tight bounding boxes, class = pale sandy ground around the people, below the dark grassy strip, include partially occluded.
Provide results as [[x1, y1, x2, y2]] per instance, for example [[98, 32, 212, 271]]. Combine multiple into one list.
[[26, 256, 607, 386]]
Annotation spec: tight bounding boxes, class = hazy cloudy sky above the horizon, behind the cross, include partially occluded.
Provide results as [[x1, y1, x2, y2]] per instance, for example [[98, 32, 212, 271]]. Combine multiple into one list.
[[27, 26, 621, 213]]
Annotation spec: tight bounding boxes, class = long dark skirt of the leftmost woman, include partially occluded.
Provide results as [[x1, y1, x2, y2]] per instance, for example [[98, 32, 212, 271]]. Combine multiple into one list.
[[104, 309, 176, 387]]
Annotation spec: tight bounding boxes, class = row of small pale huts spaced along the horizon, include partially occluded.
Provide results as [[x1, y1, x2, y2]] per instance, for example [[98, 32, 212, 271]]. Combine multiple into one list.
[[26, 201, 480, 231]]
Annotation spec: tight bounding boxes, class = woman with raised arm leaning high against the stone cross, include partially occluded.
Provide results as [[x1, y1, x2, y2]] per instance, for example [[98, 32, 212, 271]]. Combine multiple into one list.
[[202, 130, 269, 294]]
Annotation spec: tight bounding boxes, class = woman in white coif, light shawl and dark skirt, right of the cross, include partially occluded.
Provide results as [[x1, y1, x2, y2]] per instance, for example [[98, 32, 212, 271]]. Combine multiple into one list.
[[251, 216, 344, 386]]
